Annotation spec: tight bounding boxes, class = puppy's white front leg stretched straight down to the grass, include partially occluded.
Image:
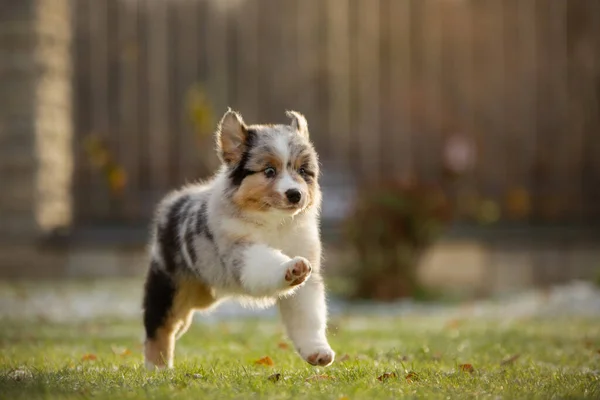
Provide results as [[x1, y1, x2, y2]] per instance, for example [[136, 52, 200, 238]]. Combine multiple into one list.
[[279, 274, 335, 366]]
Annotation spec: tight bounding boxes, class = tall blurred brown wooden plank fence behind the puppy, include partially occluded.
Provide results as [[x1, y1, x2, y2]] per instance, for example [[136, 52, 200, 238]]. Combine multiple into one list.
[[74, 0, 600, 225]]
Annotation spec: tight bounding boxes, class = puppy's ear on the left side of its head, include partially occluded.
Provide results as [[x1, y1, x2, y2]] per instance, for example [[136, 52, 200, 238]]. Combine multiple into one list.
[[216, 108, 248, 165]]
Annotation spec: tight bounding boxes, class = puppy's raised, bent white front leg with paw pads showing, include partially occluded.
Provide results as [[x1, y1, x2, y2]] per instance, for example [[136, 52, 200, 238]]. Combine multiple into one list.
[[240, 244, 312, 296]]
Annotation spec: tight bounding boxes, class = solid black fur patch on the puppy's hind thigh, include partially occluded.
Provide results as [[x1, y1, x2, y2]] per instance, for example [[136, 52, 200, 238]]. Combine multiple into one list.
[[143, 261, 176, 339]]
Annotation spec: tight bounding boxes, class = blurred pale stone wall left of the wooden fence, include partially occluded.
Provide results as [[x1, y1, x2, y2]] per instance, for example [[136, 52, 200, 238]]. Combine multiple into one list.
[[0, 0, 73, 244]]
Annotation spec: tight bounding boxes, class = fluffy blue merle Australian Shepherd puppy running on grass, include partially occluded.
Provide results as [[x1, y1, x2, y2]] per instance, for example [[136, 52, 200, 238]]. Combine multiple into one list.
[[143, 110, 334, 369]]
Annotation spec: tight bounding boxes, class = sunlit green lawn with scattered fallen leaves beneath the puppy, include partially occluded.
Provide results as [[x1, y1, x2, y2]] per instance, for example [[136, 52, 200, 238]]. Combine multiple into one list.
[[0, 316, 600, 400]]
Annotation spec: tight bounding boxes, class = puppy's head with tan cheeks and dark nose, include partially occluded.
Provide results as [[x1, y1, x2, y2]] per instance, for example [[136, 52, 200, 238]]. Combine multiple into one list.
[[217, 110, 320, 215]]
